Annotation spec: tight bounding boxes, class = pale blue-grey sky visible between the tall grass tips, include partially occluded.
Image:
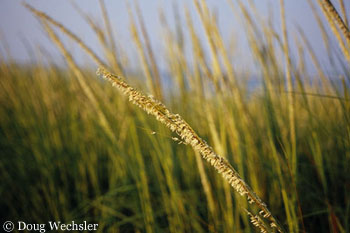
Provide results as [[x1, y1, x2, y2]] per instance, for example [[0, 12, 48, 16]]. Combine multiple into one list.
[[0, 0, 350, 73]]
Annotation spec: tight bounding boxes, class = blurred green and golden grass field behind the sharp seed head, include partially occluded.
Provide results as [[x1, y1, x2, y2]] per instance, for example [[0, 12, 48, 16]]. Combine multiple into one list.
[[0, 0, 350, 233]]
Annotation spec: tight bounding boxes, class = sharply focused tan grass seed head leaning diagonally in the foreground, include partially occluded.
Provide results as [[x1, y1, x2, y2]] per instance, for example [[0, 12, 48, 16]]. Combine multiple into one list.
[[97, 68, 282, 232]]
